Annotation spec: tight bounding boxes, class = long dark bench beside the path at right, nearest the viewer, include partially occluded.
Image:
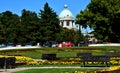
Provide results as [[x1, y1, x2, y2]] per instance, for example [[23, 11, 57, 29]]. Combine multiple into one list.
[[81, 56, 110, 67]]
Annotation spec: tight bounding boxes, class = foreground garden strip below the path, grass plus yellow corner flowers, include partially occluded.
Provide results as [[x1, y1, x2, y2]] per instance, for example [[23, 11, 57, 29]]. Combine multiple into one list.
[[11, 66, 120, 73]]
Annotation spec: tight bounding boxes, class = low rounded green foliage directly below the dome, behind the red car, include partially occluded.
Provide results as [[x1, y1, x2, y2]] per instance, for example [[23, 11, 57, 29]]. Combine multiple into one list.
[[56, 28, 84, 43]]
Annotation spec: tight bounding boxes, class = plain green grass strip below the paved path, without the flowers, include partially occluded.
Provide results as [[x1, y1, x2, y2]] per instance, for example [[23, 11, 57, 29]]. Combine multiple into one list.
[[14, 68, 100, 73]]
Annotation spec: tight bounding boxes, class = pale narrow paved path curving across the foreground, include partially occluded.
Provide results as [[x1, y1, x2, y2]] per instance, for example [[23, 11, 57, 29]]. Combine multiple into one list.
[[0, 66, 108, 73]]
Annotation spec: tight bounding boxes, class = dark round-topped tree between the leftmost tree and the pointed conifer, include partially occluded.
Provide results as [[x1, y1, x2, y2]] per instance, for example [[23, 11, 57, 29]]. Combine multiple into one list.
[[21, 9, 41, 44]]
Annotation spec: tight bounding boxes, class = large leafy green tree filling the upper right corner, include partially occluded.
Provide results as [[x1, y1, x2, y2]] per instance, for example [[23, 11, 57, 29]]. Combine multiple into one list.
[[76, 0, 120, 42]]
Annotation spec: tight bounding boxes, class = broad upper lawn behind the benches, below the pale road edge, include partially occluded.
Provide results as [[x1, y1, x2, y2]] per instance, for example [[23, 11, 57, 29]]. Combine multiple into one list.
[[0, 46, 120, 59]]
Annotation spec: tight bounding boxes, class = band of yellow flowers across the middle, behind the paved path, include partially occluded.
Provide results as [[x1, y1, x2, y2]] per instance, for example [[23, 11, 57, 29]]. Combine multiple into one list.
[[0, 55, 120, 65]]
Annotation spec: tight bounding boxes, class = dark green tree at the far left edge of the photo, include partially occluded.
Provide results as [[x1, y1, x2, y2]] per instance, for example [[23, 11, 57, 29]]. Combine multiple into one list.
[[0, 11, 20, 43]]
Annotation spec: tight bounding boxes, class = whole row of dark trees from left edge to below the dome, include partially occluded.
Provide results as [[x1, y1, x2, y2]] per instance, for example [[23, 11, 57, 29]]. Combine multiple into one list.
[[0, 3, 84, 45]]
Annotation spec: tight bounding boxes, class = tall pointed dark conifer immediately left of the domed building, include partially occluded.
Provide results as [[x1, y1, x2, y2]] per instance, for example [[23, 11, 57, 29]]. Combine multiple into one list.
[[39, 3, 60, 43]]
